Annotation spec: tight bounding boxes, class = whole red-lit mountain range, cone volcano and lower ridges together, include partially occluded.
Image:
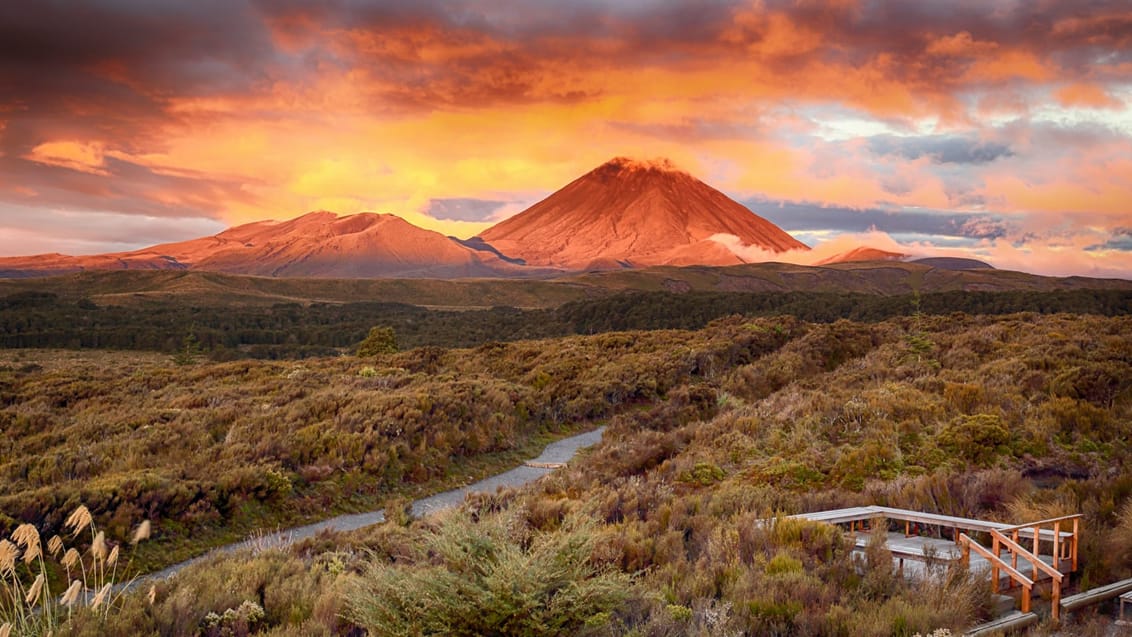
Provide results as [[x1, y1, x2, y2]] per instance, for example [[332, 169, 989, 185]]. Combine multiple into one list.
[[0, 157, 1009, 278]]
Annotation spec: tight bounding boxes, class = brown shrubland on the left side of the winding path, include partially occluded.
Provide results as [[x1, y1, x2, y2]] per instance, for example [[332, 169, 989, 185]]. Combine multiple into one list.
[[0, 319, 790, 566]]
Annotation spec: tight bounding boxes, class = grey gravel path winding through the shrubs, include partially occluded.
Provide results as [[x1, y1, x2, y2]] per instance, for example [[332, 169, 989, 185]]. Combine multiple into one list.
[[136, 427, 606, 587]]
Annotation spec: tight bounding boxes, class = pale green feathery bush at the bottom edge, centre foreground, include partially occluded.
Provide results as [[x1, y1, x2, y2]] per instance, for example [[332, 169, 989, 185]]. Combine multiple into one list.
[[346, 511, 629, 636]]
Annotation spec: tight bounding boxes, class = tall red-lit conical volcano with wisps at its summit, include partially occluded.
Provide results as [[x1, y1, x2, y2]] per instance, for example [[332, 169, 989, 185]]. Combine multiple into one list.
[[480, 157, 808, 269]]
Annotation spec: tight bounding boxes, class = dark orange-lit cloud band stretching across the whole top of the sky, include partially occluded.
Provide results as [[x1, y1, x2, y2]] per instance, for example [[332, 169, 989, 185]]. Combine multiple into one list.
[[0, 0, 1132, 128]]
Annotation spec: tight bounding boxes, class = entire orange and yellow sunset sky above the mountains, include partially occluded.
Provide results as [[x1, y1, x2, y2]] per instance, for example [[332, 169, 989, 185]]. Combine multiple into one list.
[[0, 0, 1132, 278]]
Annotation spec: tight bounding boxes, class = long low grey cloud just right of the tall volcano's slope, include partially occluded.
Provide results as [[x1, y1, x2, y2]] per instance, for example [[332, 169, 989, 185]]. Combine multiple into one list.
[[743, 199, 1009, 239]]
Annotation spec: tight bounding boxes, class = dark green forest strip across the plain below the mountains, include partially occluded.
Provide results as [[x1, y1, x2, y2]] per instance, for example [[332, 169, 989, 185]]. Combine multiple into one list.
[[0, 290, 1132, 361]]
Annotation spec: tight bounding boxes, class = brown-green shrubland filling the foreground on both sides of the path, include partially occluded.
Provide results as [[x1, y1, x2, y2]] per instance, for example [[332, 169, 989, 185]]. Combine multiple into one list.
[[0, 312, 1132, 637]]
